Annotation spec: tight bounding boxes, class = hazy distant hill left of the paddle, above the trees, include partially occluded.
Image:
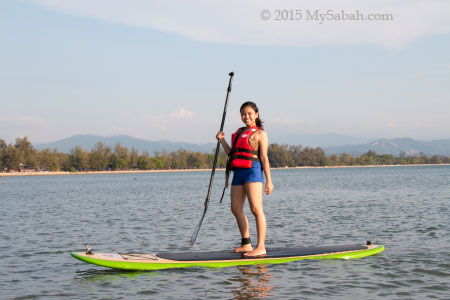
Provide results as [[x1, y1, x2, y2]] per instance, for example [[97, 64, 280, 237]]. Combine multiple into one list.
[[34, 135, 216, 154]]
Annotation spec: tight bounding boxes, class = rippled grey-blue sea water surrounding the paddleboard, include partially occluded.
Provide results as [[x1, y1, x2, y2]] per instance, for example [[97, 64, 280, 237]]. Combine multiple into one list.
[[0, 166, 450, 299]]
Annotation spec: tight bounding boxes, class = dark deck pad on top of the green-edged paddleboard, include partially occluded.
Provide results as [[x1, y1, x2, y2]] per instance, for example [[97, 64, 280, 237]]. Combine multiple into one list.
[[156, 245, 368, 261]]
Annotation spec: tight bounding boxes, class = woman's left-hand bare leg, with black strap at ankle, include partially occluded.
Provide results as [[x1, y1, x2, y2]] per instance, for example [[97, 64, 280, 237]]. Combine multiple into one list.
[[231, 185, 253, 252]]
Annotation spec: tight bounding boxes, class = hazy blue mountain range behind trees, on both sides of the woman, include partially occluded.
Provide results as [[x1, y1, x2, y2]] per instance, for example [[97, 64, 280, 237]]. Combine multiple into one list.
[[34, 134, 450, 156]]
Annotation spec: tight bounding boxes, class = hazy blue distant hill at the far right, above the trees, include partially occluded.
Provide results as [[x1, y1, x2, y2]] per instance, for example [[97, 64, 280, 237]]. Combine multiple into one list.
[[324, 138, 450, 156]]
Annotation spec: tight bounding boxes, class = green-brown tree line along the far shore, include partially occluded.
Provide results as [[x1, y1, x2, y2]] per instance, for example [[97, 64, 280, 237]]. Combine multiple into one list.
[[0, 137, 450, 172]]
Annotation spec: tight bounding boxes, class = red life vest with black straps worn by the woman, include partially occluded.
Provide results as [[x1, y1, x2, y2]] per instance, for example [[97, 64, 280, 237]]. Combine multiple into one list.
[[229, 126, 262, 170]]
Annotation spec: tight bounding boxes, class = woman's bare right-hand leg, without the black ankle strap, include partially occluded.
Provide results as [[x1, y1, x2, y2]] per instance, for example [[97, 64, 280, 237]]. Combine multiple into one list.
[[244, 182, 267, 256]]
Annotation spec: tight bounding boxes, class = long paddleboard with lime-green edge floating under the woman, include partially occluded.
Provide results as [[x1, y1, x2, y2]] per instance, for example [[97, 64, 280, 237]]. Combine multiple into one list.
[[70, 242, 384, 270]]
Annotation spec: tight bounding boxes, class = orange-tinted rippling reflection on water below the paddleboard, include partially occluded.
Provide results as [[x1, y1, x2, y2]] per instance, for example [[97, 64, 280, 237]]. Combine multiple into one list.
[[228, 265, 273, 300]]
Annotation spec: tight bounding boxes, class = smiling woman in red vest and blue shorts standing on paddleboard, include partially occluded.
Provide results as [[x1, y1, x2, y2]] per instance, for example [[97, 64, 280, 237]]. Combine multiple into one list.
[[216, 102, 273, 256]]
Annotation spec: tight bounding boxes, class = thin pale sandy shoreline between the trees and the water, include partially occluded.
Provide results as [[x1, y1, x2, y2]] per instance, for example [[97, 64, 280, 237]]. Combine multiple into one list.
[[0, 164, 450, 177]]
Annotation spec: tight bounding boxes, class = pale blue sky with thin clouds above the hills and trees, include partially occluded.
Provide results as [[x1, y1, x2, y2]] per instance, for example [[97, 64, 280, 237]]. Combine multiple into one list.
[[0, 0, 450, 143]]
